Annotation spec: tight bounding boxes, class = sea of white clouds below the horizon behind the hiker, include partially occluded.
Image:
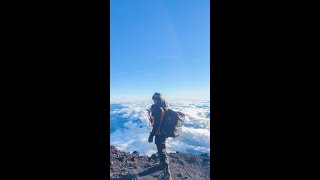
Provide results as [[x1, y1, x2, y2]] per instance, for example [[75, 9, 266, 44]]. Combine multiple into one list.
[[110, 100, 210, 156]]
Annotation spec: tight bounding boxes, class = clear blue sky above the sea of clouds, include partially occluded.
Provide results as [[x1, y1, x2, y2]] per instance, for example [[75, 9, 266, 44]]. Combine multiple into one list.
[[110, 0, 210, 99]]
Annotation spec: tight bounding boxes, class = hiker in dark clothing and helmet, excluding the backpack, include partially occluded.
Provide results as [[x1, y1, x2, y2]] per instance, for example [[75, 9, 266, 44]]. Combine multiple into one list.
[[148, 92, 172, 180]]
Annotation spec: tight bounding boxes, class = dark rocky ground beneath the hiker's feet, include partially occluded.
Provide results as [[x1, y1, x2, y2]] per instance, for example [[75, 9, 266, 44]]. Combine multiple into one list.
[[110, 145, 210, 180]]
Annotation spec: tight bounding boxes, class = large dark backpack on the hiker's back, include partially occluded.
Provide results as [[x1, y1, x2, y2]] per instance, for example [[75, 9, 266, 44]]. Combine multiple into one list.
[[161, 109, 185, 138]]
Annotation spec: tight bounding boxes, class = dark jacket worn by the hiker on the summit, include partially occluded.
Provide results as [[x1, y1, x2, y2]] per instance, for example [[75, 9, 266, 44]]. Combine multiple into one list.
[[151, 100, 168, 136]]
